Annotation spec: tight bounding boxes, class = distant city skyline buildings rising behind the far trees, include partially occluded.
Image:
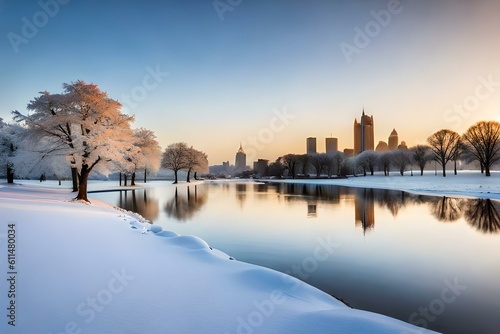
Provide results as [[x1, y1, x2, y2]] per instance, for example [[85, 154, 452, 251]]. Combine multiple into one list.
[[210, 109, 407, 174]]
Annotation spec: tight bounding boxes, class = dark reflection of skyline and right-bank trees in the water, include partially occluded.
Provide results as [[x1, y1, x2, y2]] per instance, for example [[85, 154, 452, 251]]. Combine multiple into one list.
[[260, 183, 500, 233]]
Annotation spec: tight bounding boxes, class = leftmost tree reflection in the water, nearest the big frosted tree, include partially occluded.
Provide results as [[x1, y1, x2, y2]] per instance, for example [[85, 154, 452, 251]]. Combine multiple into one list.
[[118, 189, 159, 221]]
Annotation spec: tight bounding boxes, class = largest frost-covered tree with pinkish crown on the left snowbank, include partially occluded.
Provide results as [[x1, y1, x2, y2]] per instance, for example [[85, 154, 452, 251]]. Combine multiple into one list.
[[13, 80, 134, 201]]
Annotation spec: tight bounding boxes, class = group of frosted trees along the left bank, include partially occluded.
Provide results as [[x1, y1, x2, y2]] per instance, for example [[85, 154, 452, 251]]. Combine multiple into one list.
[[0, 81, 208, 201]]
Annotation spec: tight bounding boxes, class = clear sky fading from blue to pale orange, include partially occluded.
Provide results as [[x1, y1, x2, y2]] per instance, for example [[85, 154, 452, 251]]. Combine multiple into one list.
[[0, 0, 500, 165]]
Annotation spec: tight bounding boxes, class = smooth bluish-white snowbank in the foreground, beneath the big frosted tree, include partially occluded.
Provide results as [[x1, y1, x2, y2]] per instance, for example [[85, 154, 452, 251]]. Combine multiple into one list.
[[0, 181, 433, 334]]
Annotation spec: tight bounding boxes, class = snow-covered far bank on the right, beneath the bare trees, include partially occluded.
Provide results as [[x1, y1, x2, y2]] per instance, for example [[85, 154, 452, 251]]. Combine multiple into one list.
[[262, 171, 500, 199]]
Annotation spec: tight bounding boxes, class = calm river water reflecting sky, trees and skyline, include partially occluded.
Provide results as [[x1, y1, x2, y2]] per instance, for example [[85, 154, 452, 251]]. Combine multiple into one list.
[[91, 182, 500, 333]]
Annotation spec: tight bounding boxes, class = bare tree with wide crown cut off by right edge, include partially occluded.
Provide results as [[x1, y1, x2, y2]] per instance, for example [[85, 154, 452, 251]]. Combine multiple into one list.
[[463, 121, 500, 176]]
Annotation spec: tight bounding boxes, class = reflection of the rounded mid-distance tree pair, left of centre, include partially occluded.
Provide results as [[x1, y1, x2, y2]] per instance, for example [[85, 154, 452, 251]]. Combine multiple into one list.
[[164, 185, 208, 222]]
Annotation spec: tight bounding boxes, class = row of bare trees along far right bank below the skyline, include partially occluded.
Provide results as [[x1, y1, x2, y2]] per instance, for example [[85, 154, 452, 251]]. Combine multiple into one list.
[[260, 121, 500, 178]]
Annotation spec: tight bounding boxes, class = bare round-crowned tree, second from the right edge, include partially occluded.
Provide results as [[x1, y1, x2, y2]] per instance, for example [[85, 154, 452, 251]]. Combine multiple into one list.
[[427, 129, 461, 176]]
